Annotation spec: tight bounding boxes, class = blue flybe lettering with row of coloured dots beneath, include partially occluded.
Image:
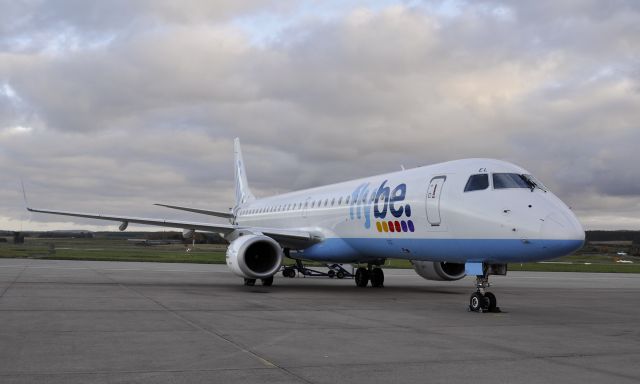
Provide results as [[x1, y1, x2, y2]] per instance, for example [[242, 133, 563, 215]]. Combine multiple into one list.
[[349, 180, 414, 232]]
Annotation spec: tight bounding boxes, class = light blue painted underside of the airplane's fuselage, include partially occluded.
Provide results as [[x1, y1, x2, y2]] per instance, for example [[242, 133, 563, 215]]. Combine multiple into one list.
[[300, 238, 584, 264]]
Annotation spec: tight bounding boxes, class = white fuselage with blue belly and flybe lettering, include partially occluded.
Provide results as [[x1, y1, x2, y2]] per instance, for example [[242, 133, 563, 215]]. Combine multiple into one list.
[[235, 159, 584, 263]]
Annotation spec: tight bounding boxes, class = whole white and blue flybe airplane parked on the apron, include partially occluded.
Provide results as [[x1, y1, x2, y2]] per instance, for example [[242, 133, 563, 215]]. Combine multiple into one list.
[[25, 138, 585, 312]]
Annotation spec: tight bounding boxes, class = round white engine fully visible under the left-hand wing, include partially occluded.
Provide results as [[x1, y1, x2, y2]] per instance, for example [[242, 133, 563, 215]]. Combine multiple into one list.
[[227, 235, 284, 279]]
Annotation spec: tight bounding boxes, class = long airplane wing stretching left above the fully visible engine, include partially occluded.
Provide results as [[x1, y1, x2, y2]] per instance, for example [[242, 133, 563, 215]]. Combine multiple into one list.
[[27, 207, 322, 249]]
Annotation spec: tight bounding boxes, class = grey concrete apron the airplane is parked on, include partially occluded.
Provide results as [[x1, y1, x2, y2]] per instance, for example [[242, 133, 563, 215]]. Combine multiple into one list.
[[0, 259, 640, 384]]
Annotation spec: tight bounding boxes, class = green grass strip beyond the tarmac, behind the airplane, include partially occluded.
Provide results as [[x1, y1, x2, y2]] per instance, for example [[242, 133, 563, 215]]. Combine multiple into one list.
[[0, 238, 640, 273]]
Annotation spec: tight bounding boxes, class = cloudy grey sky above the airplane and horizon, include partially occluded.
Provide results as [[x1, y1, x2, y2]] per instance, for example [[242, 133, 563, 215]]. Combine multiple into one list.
[[0, 0, 640, 230]]
